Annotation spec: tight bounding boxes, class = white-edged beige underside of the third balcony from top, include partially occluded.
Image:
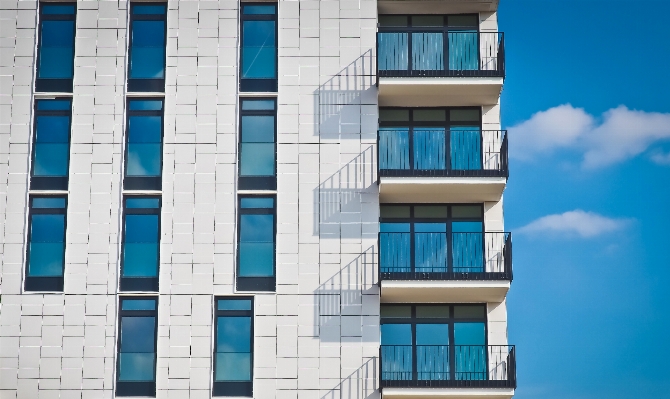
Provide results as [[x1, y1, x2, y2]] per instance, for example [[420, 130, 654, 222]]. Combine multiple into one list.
[[381, 280, 510, 303]]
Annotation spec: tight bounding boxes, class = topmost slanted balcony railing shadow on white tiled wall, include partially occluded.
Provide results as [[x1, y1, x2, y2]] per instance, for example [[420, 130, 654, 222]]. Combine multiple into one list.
[[314, 49, 377, 139]]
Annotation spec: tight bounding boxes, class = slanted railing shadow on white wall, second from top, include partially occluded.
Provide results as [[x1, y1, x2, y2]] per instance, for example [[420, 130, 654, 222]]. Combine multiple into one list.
[[314, 146, 378, 239]]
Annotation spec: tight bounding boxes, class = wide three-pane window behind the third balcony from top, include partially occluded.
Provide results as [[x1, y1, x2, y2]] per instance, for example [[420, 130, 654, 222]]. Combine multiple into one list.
[[379, 204, 485, 278]]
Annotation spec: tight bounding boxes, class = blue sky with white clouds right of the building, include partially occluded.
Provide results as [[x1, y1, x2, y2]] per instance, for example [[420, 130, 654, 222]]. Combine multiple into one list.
[[499, 0, 670, 399]]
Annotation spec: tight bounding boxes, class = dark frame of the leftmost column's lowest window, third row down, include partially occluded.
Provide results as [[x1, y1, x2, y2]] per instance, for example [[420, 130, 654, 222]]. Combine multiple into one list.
[[24, 195, 68, 292]]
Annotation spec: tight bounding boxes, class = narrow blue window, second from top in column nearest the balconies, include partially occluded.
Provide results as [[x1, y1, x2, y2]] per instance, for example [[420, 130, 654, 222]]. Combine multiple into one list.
[[239, 99, 277, 190]]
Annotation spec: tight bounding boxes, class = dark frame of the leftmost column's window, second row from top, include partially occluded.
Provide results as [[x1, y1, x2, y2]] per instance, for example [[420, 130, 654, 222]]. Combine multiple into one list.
[[30, 97, 72, 191]]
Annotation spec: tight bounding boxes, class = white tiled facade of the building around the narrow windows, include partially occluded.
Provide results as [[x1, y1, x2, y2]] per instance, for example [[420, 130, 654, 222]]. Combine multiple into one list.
[[0, 0, 507, 399]]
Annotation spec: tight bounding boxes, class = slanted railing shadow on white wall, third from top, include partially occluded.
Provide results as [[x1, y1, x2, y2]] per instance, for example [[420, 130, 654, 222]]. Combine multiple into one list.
[[314, 246, 379, 343]]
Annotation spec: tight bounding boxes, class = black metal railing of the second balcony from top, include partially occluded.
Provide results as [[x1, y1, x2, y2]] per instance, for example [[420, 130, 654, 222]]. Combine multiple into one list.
[[377, 130, 509, 177]]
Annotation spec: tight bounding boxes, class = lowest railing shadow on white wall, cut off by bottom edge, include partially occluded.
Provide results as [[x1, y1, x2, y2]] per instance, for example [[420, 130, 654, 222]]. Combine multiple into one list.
[[321, 358, 381, 399]]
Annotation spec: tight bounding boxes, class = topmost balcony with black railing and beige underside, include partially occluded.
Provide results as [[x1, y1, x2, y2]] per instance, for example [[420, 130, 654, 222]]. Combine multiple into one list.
[[377, 31, 505, 107]]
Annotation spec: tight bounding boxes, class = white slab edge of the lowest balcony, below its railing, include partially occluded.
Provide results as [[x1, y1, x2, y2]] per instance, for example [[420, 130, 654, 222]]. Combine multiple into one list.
[[382, 388, 514, 399]]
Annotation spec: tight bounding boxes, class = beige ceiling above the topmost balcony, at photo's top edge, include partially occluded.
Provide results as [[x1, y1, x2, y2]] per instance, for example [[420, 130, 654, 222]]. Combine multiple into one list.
[[377, 0, 499, 14]]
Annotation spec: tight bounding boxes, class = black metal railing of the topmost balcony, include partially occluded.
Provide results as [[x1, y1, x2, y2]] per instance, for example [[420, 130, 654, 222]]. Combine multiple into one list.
[[377, 28, 505, 78]]
